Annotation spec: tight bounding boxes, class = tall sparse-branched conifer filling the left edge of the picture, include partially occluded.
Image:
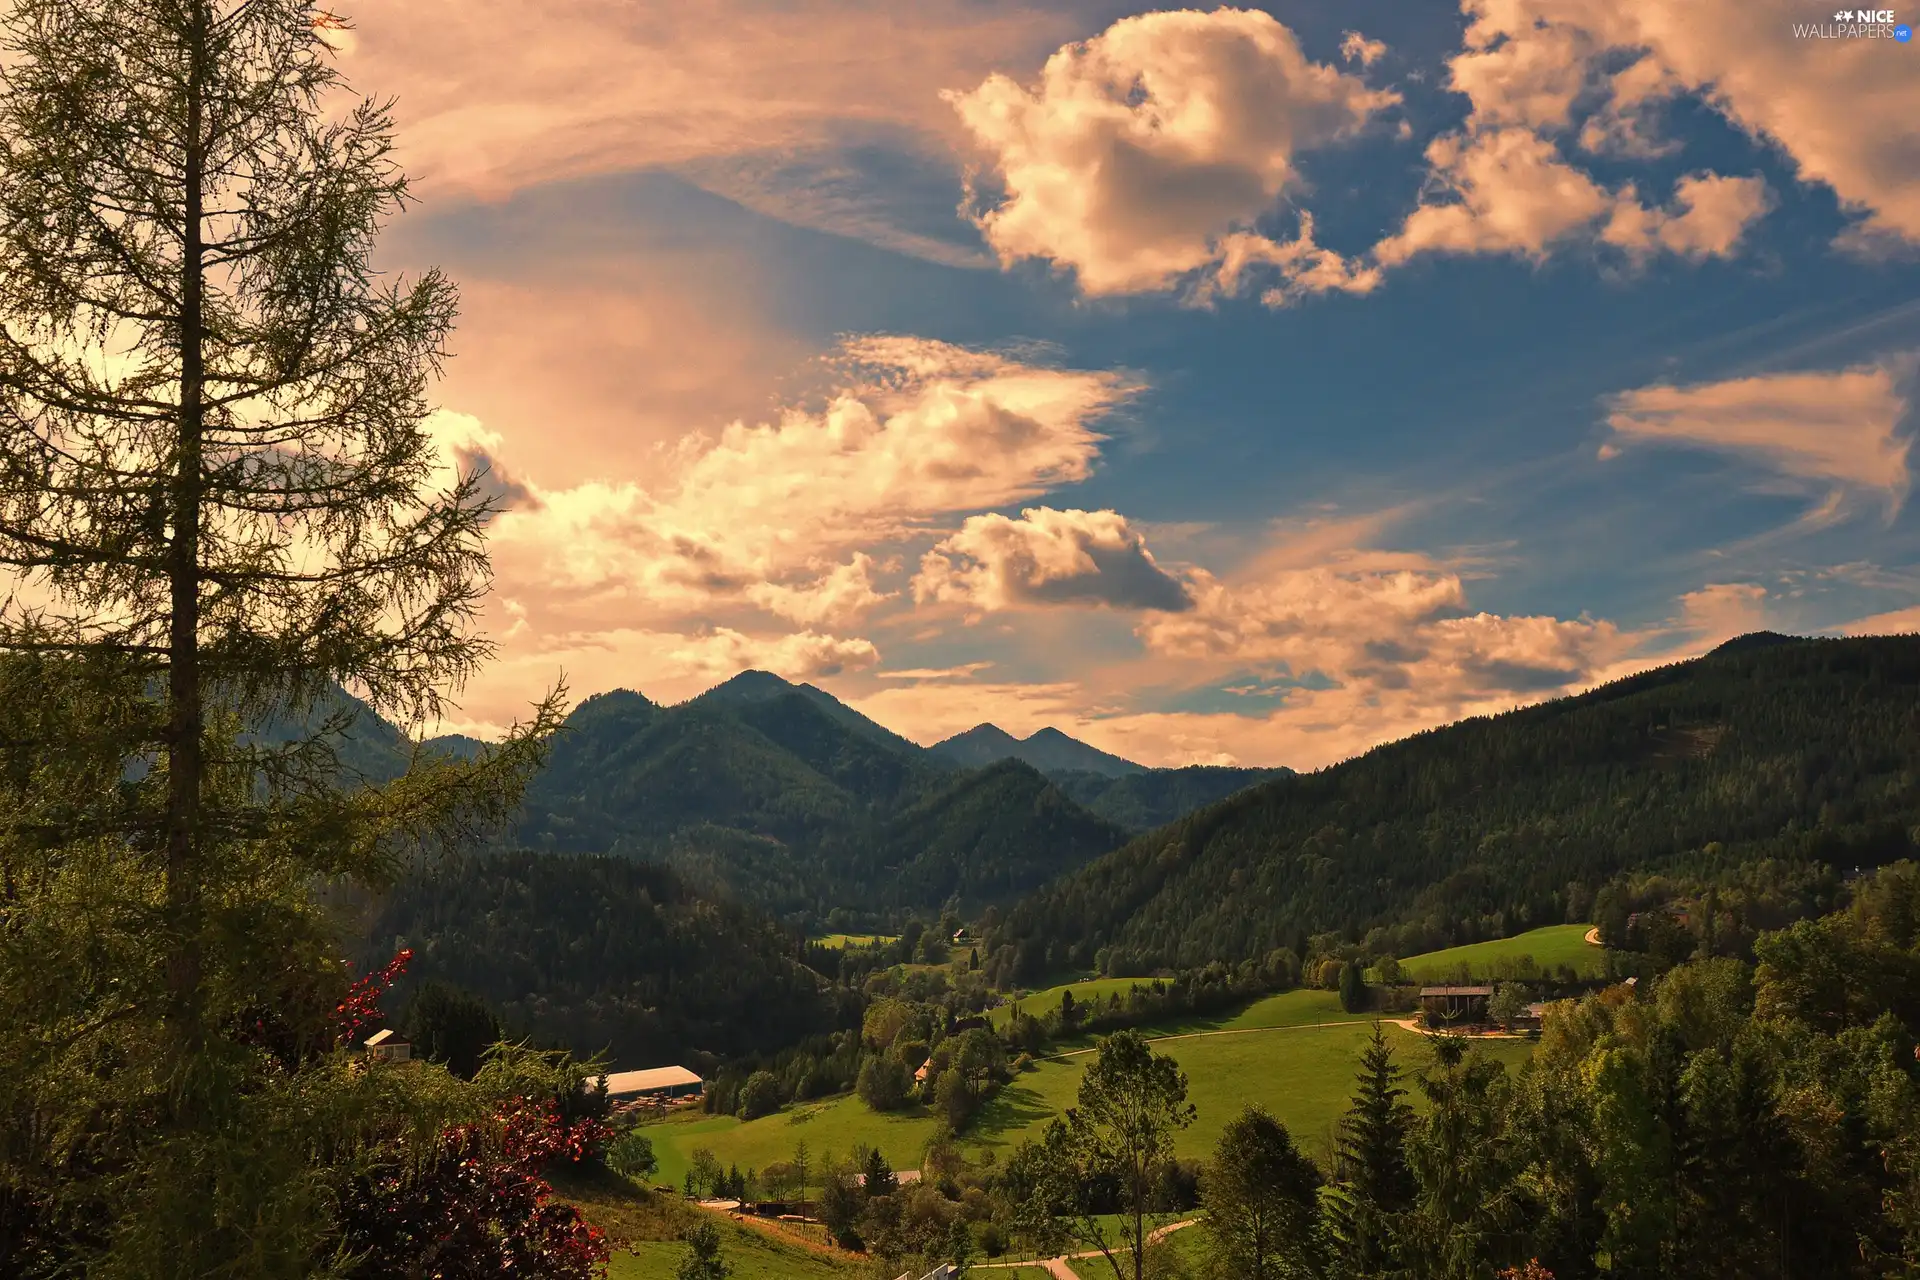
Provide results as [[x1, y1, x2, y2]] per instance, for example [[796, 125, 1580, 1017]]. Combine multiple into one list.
[[0, 0, 557, 1276]]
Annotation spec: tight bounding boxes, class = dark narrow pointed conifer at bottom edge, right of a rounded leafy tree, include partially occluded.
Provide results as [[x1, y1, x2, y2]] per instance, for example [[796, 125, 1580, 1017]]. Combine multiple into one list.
[[1329, 1023, 1417, 1276]]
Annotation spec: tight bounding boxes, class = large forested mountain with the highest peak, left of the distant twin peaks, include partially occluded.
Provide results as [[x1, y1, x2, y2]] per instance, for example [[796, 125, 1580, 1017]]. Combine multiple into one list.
[[513, 672, 1127, 917]]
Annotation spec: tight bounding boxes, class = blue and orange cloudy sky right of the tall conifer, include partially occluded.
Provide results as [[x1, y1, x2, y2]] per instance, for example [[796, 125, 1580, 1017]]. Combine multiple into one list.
[[334, 0, 1920, 770]]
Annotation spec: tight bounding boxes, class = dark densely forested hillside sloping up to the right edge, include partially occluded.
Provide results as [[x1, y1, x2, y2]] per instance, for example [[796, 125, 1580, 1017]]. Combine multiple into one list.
[[987, 635, 1920, 975]]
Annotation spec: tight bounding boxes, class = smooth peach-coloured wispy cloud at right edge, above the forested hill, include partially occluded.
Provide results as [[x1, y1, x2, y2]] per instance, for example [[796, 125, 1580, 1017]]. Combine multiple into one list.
[[1607, 367, 1908, 510]]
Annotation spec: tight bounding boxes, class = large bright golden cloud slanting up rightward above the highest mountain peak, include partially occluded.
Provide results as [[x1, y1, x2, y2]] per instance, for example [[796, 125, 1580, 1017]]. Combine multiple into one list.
[[466, 336, 1139, 629]]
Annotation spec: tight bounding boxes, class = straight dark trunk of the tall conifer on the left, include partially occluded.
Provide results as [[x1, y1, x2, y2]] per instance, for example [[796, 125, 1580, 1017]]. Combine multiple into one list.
[[167, 4, 207, 1050]]
